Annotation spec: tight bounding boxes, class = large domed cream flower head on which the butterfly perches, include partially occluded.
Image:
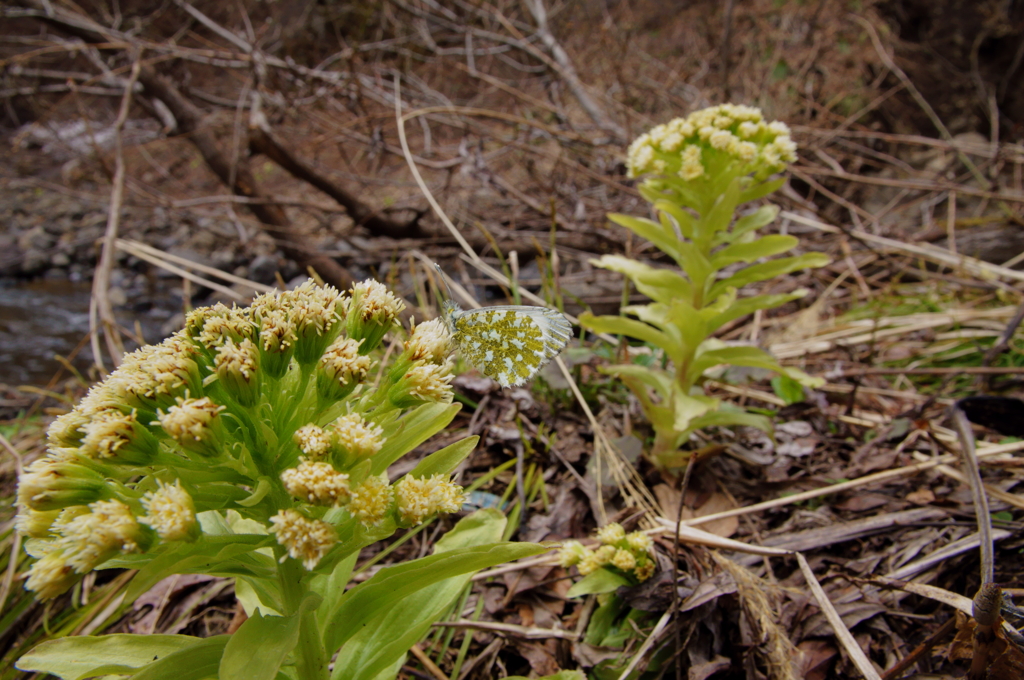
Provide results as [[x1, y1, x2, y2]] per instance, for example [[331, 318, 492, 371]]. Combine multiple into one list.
[[15, 281, 463, 599]]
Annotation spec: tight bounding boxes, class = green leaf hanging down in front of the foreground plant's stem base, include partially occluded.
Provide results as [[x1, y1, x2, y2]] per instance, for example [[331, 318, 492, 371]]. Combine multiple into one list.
[[218, 593, 323, 680]]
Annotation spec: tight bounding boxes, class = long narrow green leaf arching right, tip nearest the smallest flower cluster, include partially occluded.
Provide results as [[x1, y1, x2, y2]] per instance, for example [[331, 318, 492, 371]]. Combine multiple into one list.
[[325, 543, 547, 652]]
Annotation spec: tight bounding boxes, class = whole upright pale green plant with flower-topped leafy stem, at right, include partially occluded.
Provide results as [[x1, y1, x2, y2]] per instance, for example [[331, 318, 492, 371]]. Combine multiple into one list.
[[580, 104, 829, 467]]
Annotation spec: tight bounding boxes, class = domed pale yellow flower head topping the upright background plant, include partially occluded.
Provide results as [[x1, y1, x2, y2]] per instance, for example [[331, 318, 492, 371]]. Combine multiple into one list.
[[627, 103, 797, 181]]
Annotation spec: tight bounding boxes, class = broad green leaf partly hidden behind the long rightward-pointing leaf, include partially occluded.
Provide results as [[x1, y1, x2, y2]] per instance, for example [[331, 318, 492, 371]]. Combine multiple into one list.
[[333, 510, 507, 680]]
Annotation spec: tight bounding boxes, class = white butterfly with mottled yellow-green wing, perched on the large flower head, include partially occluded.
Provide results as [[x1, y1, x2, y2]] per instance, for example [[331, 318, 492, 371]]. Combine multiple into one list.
[[435, 265, 572, 387]]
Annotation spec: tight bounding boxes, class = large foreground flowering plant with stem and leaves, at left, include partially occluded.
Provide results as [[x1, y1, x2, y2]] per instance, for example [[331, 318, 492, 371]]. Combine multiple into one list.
[[16, 281, 543, 680]]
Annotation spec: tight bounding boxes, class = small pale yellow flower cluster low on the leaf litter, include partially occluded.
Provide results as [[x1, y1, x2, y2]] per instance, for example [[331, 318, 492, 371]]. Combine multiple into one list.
[[558, 522, 654, 583]]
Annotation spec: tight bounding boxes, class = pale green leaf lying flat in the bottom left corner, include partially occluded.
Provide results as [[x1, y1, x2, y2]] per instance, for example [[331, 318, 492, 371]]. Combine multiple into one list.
[[14, 634, 220, 680]]
